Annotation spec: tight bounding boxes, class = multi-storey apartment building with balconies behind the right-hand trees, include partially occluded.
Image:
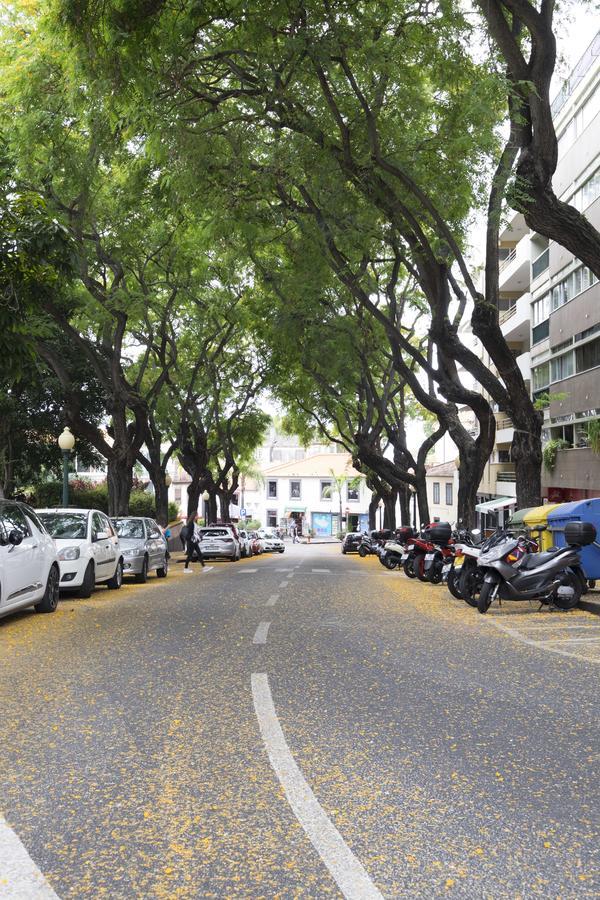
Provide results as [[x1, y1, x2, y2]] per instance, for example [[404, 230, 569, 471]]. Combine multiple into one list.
[[490, 32, 600, 510]]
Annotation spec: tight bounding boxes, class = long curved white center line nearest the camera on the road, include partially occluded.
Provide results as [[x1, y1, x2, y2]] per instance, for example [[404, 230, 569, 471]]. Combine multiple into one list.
[[252, 673, 383, 900]]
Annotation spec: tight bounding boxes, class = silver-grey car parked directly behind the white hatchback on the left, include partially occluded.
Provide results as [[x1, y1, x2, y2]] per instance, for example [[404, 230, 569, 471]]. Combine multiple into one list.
[[111, 516, 169, 584]]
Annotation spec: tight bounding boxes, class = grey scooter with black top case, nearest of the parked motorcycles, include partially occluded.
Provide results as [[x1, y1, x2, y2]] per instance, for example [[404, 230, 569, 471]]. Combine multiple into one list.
[[477, 522, 596, 614]]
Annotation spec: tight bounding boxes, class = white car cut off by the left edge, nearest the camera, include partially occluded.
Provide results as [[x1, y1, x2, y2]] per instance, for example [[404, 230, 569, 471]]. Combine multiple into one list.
[[0, 500, 60, 616]]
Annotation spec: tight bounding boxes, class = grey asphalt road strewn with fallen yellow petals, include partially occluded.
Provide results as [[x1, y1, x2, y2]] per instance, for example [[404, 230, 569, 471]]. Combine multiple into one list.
[[0, 545, 600, 900]]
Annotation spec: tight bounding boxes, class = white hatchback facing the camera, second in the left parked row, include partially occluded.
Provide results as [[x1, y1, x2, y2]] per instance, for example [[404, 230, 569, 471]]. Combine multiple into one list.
[[37, 508, 123, 597]]
